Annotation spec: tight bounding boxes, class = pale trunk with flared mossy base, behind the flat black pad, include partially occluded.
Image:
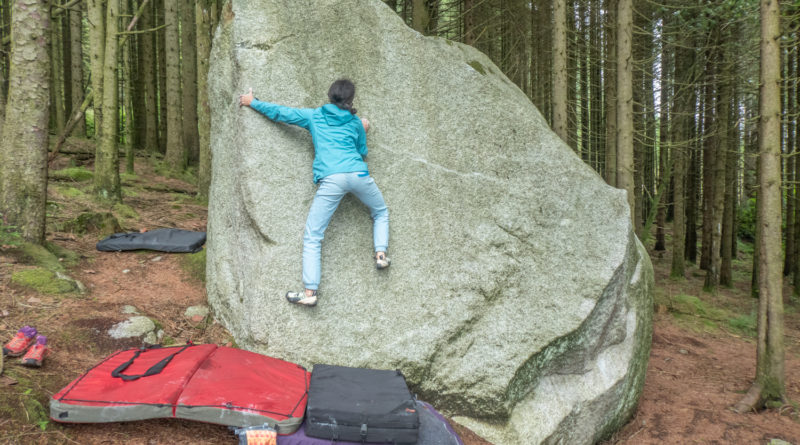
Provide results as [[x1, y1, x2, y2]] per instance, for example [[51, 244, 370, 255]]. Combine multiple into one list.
[[94, 0, 122, 202]]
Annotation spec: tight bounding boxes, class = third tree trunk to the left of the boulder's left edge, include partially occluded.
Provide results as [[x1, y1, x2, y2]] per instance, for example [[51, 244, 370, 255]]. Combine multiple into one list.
[[164, 0, 186, 172]]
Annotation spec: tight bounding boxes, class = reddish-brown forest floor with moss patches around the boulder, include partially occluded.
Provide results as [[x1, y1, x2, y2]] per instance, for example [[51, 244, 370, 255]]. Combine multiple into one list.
[[0, 153, 800, 445]]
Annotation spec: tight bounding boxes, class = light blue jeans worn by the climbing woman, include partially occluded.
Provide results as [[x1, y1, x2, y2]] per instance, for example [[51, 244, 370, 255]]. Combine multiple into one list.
[[303, 172, 389, 290]]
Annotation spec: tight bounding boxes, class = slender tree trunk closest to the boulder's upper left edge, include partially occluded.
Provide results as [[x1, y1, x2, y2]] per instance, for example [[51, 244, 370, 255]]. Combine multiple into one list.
[[195, 0, 217, 200]]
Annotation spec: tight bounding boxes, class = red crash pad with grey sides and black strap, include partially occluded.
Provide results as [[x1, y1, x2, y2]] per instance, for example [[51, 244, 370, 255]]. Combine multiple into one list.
[[50, 345, 310, 434]]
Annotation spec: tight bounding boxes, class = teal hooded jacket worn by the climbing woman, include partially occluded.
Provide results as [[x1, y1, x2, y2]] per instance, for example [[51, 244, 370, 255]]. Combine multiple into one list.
[[250, 99, 368, 183]]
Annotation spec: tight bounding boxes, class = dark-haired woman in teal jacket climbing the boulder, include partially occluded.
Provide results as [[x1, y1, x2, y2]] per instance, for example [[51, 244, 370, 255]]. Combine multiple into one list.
[[239, 79, 390, 306]]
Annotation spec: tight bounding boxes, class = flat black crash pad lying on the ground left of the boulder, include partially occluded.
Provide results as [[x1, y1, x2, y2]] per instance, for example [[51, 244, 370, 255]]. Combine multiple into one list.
[[97, 229, 206, 253]]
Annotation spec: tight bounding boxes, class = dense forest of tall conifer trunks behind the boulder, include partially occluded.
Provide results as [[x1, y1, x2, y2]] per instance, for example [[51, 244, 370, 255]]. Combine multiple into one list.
[[0, 0, 800, 443]]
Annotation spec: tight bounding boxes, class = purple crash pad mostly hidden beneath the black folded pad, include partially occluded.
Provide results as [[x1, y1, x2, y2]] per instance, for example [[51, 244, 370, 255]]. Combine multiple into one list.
[[278, 400, 464, 445]]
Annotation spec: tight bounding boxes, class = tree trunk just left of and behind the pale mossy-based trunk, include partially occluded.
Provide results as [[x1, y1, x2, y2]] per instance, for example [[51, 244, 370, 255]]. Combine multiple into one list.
[[86, 0, 106, 141]]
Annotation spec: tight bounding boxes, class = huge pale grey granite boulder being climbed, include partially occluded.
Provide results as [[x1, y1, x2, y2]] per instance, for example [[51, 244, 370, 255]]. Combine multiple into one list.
[[207, 0, 653, 445]]
